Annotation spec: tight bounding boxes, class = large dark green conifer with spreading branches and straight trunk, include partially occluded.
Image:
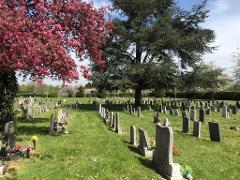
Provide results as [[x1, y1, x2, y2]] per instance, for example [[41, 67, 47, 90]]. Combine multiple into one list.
[[93, 0, 215, 105]]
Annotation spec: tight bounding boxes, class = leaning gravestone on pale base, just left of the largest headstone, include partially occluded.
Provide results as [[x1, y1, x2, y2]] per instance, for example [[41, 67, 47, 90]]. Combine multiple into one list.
[[138, 129, 153, 157]]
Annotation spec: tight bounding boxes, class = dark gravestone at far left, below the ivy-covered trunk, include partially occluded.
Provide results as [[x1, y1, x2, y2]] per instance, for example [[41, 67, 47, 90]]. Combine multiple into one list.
[[4, 121, 16, 148]]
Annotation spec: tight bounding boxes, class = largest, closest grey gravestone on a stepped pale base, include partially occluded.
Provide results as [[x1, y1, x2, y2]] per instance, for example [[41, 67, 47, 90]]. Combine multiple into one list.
[[152, 124, 182, 180]]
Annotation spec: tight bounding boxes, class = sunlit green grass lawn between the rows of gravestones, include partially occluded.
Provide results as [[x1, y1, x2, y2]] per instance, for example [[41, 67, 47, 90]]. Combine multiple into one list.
[[6, 98, 240, 180]]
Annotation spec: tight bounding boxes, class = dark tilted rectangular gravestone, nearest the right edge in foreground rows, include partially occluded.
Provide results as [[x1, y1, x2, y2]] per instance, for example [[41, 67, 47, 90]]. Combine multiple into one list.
[[208, 122, 222, 142]]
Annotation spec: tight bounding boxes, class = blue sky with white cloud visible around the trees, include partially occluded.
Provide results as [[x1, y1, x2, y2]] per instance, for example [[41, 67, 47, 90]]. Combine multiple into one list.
[[18, 0, 240, 84]]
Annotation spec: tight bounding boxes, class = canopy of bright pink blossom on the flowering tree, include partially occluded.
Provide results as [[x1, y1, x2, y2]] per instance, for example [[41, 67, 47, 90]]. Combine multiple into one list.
[[0, 0, 111, 81]]
